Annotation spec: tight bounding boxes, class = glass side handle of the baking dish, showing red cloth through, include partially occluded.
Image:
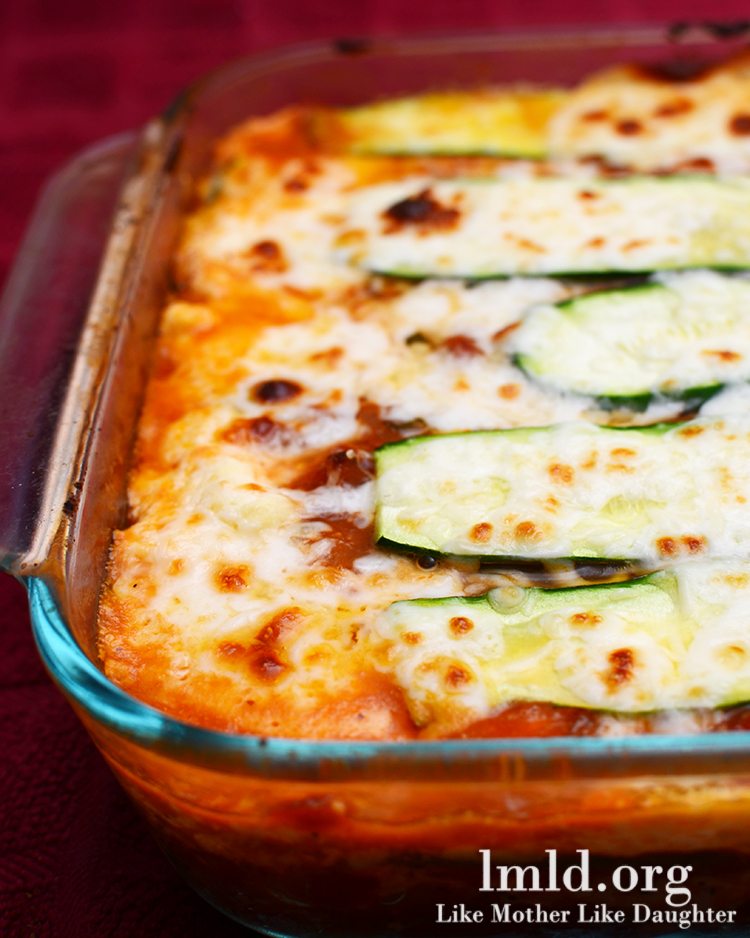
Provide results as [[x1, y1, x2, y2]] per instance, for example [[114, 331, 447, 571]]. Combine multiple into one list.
[[0, 133, 137, 573]]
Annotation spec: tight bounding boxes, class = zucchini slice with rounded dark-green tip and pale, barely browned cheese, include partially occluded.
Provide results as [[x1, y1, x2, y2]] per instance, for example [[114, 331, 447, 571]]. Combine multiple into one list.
[[508, 271, 750, 409]]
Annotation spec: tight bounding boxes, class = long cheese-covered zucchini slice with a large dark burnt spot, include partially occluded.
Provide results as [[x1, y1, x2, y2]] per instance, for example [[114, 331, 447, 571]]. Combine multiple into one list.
[[336, 176, 750, 280]]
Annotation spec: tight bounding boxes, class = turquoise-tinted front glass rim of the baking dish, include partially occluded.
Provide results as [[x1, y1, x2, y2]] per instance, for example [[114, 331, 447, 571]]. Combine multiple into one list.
[[29, 577, 750, 780]]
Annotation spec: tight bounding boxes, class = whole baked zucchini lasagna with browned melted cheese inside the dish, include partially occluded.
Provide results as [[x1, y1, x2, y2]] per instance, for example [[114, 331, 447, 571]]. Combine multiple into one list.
[[99, 51, 750, 740]]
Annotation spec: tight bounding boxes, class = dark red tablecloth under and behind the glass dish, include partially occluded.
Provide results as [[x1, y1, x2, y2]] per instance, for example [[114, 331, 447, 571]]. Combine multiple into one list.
[[0, 0, 748, 938]]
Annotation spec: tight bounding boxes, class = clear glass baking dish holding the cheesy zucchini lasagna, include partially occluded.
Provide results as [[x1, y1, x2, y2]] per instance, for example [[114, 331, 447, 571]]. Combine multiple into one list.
[[0, 24, 750, 938]]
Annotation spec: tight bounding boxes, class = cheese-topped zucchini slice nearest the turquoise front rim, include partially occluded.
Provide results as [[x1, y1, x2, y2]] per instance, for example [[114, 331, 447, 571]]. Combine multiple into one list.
[[368, 561, 750, 725]]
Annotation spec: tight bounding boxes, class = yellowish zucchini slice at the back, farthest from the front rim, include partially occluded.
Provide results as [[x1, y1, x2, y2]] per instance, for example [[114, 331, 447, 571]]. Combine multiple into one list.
[[314, 88, 567, 159]]
